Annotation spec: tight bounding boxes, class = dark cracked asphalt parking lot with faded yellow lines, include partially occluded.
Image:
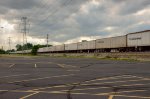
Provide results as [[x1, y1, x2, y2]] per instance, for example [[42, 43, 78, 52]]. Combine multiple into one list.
[[0, 57, 150, 99]]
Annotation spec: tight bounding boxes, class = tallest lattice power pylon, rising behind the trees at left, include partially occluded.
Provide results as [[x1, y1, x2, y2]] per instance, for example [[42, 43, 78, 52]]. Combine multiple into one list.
[[21, 17, 29, 52]]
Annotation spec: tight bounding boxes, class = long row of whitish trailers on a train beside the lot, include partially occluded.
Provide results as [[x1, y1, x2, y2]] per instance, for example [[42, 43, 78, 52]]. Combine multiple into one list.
[[14, 30, 150, 53]]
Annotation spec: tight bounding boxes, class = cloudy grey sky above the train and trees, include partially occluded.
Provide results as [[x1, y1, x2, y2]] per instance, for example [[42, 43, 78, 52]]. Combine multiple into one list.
[[0, 0, 150, 50]]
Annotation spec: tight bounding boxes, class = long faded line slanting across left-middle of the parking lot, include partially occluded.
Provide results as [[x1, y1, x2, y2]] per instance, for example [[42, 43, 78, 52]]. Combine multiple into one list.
[[6, 74, 75, 83]]
